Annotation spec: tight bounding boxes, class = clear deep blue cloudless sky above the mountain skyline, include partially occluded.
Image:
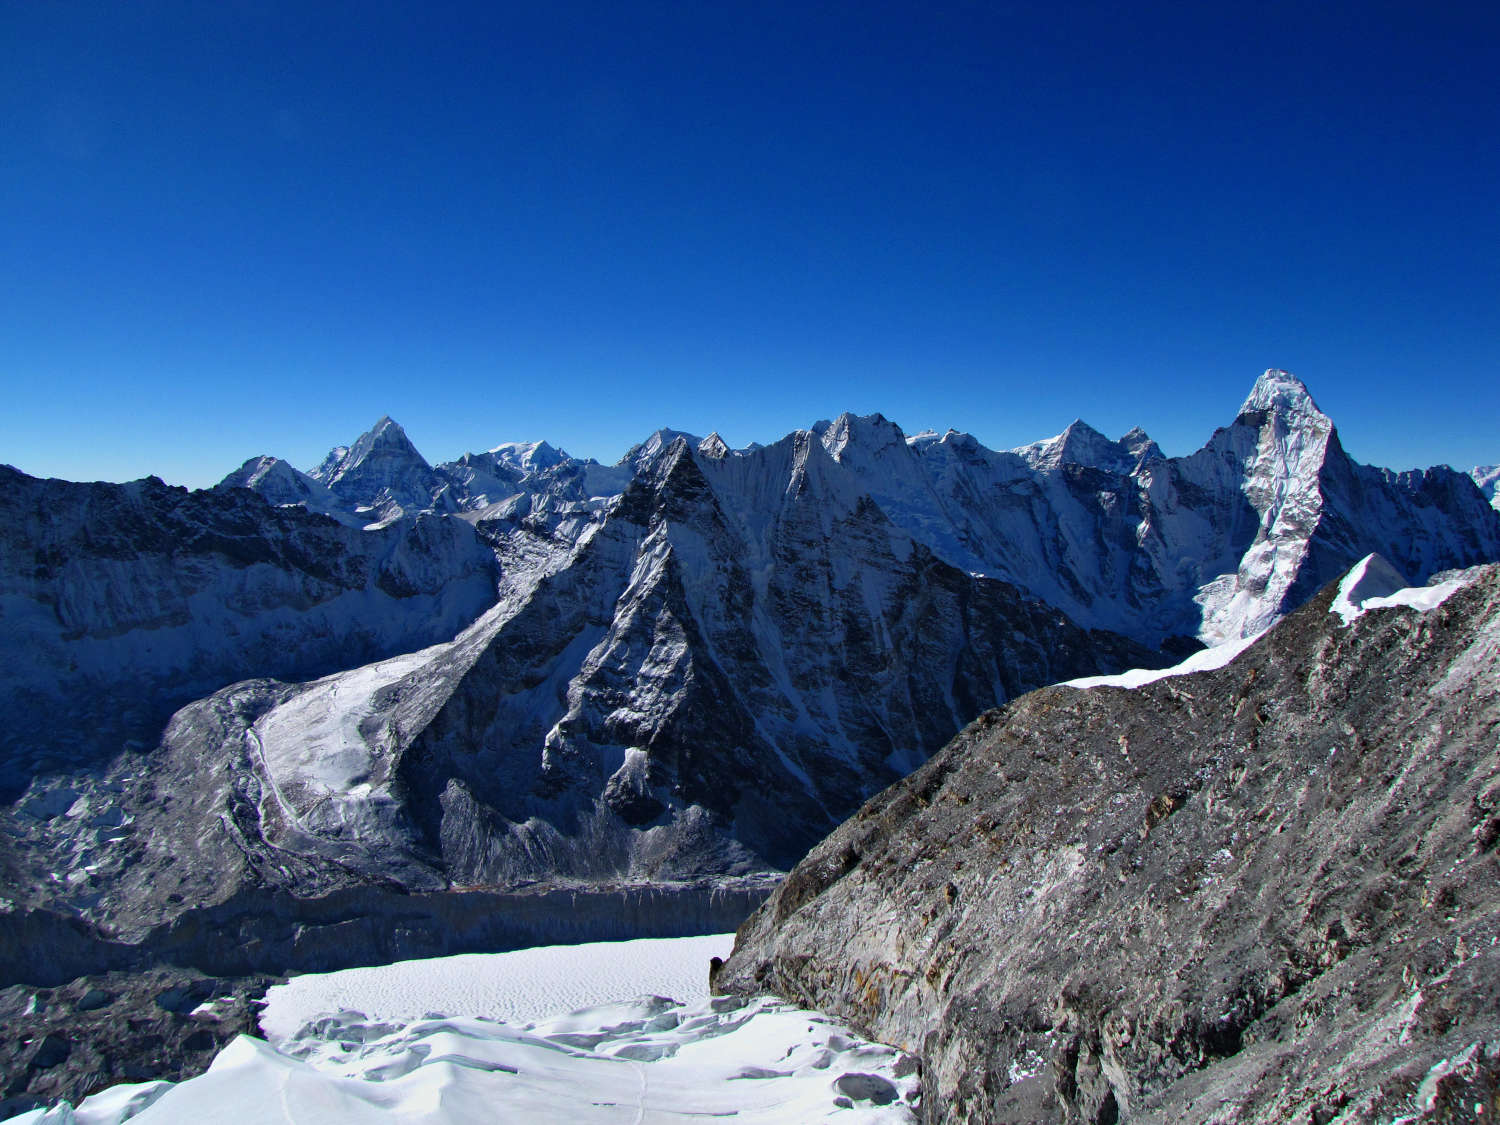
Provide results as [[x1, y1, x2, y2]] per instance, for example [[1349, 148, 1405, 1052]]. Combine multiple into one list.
[[0, 0, 1500, 485]]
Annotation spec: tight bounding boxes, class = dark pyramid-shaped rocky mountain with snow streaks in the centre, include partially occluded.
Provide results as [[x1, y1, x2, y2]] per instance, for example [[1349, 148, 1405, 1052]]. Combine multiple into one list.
[[398, 441, 1160, 884]]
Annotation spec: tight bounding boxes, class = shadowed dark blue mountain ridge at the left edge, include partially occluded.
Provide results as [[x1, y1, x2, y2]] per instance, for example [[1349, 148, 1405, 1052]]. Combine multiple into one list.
[[0, 467, 497, 800]]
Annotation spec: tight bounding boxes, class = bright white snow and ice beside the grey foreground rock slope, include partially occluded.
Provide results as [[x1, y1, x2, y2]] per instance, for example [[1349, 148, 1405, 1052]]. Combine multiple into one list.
[[12, 935, 918, 1125]]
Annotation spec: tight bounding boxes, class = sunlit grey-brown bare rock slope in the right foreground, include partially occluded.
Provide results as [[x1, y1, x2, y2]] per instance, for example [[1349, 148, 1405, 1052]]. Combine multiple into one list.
[[716, 567, 1500, 1124]]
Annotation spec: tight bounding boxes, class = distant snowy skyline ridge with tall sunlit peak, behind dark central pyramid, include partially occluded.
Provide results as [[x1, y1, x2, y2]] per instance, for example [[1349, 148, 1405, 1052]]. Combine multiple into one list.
[[224, 368, 1500, 645]]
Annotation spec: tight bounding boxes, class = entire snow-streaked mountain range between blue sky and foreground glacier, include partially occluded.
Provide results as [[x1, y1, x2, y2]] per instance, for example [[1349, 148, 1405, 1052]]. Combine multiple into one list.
[[0, 372, 1500, 929]]
